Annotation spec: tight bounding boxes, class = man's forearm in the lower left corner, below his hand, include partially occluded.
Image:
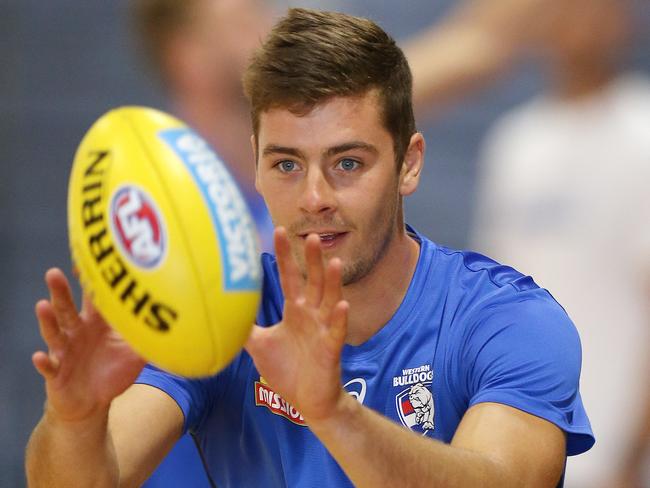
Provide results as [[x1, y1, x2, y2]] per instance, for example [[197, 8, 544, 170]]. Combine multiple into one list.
[[26, 412, 119, 488]]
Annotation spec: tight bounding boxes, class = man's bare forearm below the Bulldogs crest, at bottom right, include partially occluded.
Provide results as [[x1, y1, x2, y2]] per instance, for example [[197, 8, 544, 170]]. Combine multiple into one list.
[[306, 396, 521, 487]]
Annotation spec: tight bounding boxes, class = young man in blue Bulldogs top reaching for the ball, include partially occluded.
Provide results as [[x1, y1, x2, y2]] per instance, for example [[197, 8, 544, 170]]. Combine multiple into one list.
[[27, 9, 593, 487]]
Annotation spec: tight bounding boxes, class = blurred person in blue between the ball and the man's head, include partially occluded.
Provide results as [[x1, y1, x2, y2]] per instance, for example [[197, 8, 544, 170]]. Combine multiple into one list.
[[132, 0, 273, 488]]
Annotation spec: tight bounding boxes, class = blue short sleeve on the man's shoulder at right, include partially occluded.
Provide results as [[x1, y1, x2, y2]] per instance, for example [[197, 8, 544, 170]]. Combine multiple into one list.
[[459, 289, 594, 455]]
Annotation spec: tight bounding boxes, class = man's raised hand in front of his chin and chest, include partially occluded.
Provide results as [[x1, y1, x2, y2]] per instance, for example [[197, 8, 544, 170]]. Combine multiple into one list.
[[246, 227, 348, 423]]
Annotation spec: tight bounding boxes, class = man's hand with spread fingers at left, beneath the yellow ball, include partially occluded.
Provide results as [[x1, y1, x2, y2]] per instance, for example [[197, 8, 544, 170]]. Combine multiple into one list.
[[32, 269, 145, 421]]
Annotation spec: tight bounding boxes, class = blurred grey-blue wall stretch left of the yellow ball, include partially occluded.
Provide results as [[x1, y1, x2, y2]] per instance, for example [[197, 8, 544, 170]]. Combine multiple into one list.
[[0, 0, 167, 487]]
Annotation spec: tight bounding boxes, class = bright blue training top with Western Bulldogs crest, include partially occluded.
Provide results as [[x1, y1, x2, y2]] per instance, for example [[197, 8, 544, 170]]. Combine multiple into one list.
[[137, 230, 594, 487]]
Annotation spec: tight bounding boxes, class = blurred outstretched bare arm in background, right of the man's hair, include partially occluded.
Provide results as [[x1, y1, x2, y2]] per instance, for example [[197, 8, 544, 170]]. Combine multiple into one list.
[[404, 0, 561, 109]]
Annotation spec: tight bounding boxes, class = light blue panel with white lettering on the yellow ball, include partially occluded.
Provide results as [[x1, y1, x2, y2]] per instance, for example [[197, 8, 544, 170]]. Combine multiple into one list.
[[158, 128, 260, 291]]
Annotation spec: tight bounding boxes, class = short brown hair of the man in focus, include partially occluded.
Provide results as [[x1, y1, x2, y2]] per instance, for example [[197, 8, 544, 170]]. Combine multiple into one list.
[[243, 8, 416, 166]]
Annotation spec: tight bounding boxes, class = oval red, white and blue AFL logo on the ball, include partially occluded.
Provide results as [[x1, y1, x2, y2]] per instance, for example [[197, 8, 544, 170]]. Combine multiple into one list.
[[110, 185, 166, 269]]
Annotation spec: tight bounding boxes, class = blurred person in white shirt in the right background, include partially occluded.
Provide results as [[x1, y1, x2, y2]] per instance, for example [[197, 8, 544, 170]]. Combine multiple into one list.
[[468, 0, 650, 488]]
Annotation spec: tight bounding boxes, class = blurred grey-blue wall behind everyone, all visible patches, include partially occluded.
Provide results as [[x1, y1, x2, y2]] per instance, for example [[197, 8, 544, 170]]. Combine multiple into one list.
[[0, 0, 650, 487]]
